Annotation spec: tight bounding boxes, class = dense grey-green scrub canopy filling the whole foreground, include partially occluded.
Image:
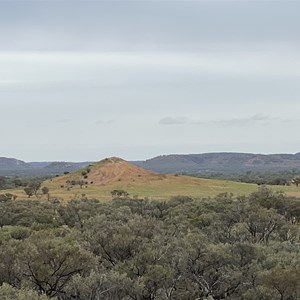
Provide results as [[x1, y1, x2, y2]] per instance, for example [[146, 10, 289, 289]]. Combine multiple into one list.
[[0, 187, 300, 300]]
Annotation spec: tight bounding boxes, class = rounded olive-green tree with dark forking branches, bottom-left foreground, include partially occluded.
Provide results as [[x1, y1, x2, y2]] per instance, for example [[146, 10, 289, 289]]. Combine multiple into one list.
[[19, 231, 92, 298]]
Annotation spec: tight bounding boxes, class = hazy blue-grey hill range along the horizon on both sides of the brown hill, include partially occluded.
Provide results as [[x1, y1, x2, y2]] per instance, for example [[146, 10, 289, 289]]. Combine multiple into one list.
[[0, 152, 300, 176]]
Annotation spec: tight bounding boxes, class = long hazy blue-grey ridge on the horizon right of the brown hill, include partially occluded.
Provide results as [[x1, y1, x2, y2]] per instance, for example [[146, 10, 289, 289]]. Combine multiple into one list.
[[133, 152, 300, 173]]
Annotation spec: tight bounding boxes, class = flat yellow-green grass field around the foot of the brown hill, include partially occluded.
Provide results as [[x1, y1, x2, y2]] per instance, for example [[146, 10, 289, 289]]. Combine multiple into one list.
[[1, 175, 300, 201]]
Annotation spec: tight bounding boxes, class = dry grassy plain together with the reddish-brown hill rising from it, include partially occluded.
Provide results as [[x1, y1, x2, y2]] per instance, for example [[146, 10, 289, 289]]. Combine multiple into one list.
[[4, 158, 300, 201]]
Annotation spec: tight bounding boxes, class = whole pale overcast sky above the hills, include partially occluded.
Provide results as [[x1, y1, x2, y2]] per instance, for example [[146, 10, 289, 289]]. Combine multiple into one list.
[[0, 0, 300, 161]]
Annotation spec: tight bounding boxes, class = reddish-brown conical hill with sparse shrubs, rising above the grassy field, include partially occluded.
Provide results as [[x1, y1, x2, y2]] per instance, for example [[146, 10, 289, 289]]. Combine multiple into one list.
[[52, 157, 167, 186]]
